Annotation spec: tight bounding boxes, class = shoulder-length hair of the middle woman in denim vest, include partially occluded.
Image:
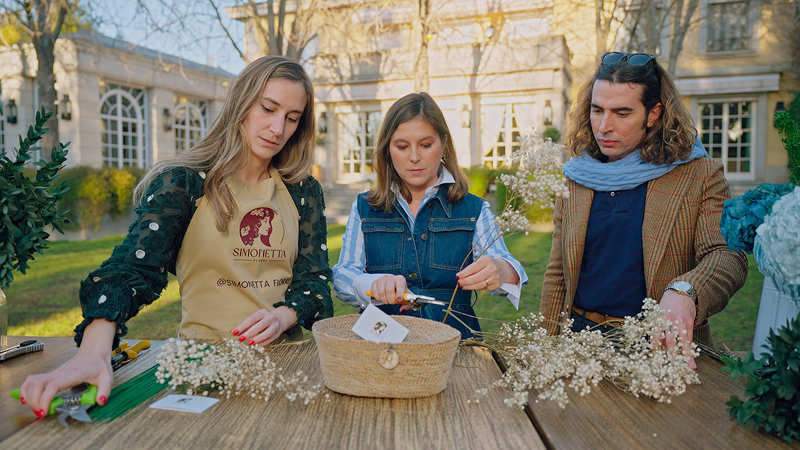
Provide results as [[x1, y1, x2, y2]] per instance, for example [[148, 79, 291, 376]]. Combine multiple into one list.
[[367, 92, 469, 212]]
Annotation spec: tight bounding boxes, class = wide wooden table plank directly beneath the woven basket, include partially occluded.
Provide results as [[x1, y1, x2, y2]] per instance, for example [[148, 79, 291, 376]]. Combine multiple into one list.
[[2, 343, 544, 449]]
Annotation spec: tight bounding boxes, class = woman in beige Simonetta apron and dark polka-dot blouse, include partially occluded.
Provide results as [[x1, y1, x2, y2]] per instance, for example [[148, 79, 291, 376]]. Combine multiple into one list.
[[20, 57, 333, 417]]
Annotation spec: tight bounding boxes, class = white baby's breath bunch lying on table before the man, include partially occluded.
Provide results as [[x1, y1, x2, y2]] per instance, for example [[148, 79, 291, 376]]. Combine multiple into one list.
[[476, 298, 700, 408]]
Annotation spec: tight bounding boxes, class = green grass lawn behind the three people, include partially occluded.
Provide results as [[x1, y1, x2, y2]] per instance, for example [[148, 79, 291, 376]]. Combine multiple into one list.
[[7, 225, 764, 350]]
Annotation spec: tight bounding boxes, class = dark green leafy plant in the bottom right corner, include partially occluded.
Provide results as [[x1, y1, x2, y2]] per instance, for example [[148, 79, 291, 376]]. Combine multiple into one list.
[[723, 315, 800, 442]]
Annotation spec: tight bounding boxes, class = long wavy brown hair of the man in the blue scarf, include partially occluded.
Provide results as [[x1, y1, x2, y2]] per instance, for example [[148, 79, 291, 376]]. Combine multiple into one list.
[[565, 55, 697, 164]]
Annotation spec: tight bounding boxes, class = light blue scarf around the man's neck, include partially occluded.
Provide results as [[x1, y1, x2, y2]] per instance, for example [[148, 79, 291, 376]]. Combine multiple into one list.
[[564, 138, 708, 192]]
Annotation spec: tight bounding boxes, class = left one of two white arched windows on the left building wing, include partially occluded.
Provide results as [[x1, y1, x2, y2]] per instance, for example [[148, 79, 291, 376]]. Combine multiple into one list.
[[100, 84, 148, 168]]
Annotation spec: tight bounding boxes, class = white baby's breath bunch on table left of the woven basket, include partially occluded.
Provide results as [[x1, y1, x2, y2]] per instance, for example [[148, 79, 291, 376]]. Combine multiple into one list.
[[156, 338, 322, 404]]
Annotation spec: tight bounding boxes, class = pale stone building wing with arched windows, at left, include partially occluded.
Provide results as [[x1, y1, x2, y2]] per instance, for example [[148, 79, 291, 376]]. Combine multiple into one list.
[[0, 32, 233, 169]]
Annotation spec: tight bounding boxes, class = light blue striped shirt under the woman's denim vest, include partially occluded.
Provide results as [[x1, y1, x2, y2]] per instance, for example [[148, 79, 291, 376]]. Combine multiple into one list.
[[333, 167, 528, 309]]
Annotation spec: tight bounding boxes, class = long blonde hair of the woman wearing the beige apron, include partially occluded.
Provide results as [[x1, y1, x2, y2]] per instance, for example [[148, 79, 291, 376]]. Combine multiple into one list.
[[134, 56, 316, 232]]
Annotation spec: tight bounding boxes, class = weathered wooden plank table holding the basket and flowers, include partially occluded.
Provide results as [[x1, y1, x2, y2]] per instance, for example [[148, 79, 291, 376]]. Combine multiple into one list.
[[0, 337, 788, 449]]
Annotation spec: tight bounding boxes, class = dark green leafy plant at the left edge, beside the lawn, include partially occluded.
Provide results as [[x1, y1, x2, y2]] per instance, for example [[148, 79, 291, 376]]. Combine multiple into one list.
[[0, 108, 69, 288]]
